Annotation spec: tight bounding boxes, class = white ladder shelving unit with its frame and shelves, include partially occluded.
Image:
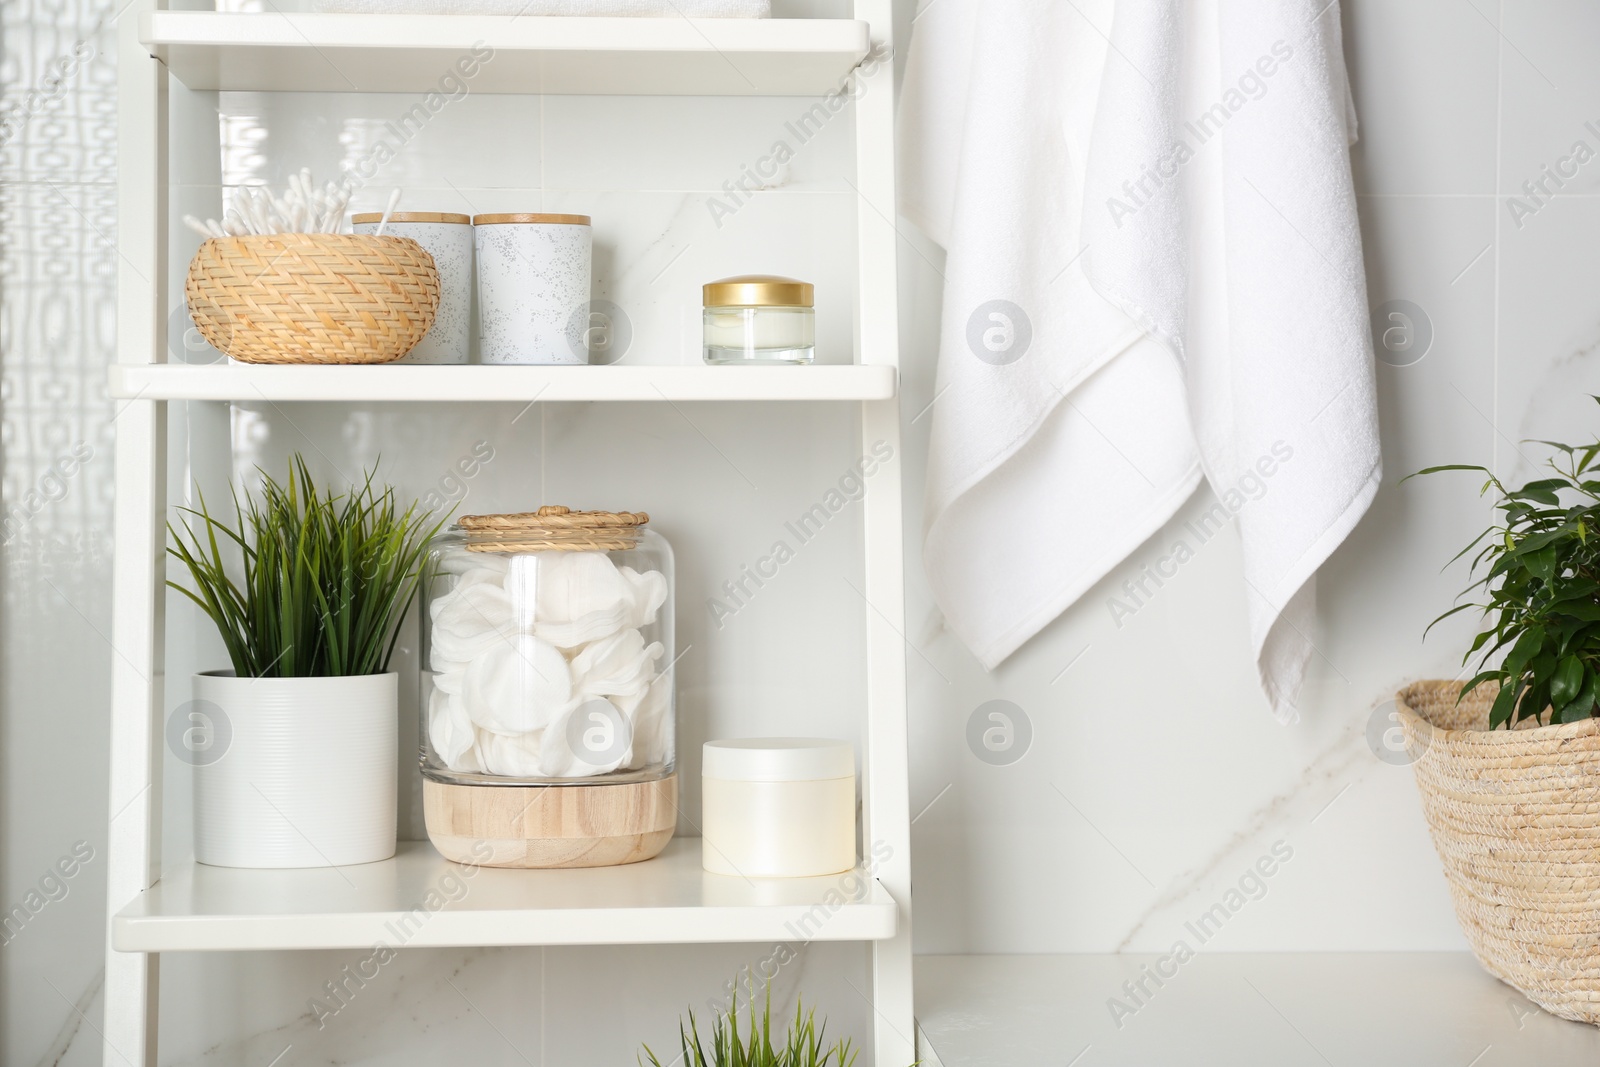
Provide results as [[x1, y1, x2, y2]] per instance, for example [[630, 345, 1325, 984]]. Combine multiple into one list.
[[102, 0, 915, 1067]]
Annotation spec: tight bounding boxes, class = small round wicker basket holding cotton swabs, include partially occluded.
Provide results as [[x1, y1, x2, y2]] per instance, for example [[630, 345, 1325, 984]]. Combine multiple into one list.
[[184, 234, 438, 363]]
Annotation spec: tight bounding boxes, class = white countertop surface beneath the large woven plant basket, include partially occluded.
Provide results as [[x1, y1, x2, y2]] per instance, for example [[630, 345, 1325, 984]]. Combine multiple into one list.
[[917, 950, 1600, 1067]]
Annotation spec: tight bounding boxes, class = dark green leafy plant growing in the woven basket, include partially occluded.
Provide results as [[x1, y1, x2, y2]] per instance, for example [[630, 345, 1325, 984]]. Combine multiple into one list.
[[1413, 397, 1600, 729]]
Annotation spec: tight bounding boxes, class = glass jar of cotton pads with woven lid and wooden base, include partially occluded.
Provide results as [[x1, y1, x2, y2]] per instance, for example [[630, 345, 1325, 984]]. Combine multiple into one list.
[[421, 507, 678, 867]]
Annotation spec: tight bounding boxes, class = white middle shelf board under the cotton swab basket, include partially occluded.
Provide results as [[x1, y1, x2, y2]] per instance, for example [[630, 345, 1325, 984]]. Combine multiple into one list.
[[110, 363, 896, 403]]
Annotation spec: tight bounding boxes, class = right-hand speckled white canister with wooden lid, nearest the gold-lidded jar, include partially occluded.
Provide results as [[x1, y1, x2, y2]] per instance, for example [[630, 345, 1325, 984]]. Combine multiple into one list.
[[472, 214, 594, 365]]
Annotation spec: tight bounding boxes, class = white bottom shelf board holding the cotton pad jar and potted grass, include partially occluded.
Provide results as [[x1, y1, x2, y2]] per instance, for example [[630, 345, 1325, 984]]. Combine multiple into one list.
[[112, 838, 896, 952]]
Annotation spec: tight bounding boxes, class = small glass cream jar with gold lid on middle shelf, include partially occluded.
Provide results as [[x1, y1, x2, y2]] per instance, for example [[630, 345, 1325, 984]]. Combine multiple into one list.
[[701, 274, 816, 363]]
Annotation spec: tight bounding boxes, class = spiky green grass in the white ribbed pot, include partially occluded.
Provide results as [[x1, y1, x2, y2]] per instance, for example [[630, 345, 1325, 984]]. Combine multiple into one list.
[[166, 454, 443, 678]]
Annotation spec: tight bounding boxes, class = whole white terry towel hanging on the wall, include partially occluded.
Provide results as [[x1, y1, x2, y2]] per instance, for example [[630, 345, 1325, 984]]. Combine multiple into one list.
[[901, 0, 1379, 717]]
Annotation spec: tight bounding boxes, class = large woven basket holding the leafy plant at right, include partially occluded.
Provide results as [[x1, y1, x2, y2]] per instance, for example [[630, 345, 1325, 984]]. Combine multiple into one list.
[[1395, 681, 1600, 1024]]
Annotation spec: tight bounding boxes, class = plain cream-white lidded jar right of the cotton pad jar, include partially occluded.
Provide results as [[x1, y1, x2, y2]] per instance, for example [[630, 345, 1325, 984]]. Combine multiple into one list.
[[701, 737, 856, 878]]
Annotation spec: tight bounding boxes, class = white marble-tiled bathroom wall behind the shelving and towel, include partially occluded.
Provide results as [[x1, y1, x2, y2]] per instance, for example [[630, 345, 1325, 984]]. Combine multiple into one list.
[[0, 0, 1600, 1067]]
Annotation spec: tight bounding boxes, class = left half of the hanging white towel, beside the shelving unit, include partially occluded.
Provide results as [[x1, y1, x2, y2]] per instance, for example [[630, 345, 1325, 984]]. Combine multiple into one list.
[[901, 0, 1200, 669]]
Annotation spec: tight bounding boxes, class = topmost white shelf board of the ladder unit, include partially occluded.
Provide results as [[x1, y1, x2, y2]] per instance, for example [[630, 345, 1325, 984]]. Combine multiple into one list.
[[139, 11, 870, 96]]
